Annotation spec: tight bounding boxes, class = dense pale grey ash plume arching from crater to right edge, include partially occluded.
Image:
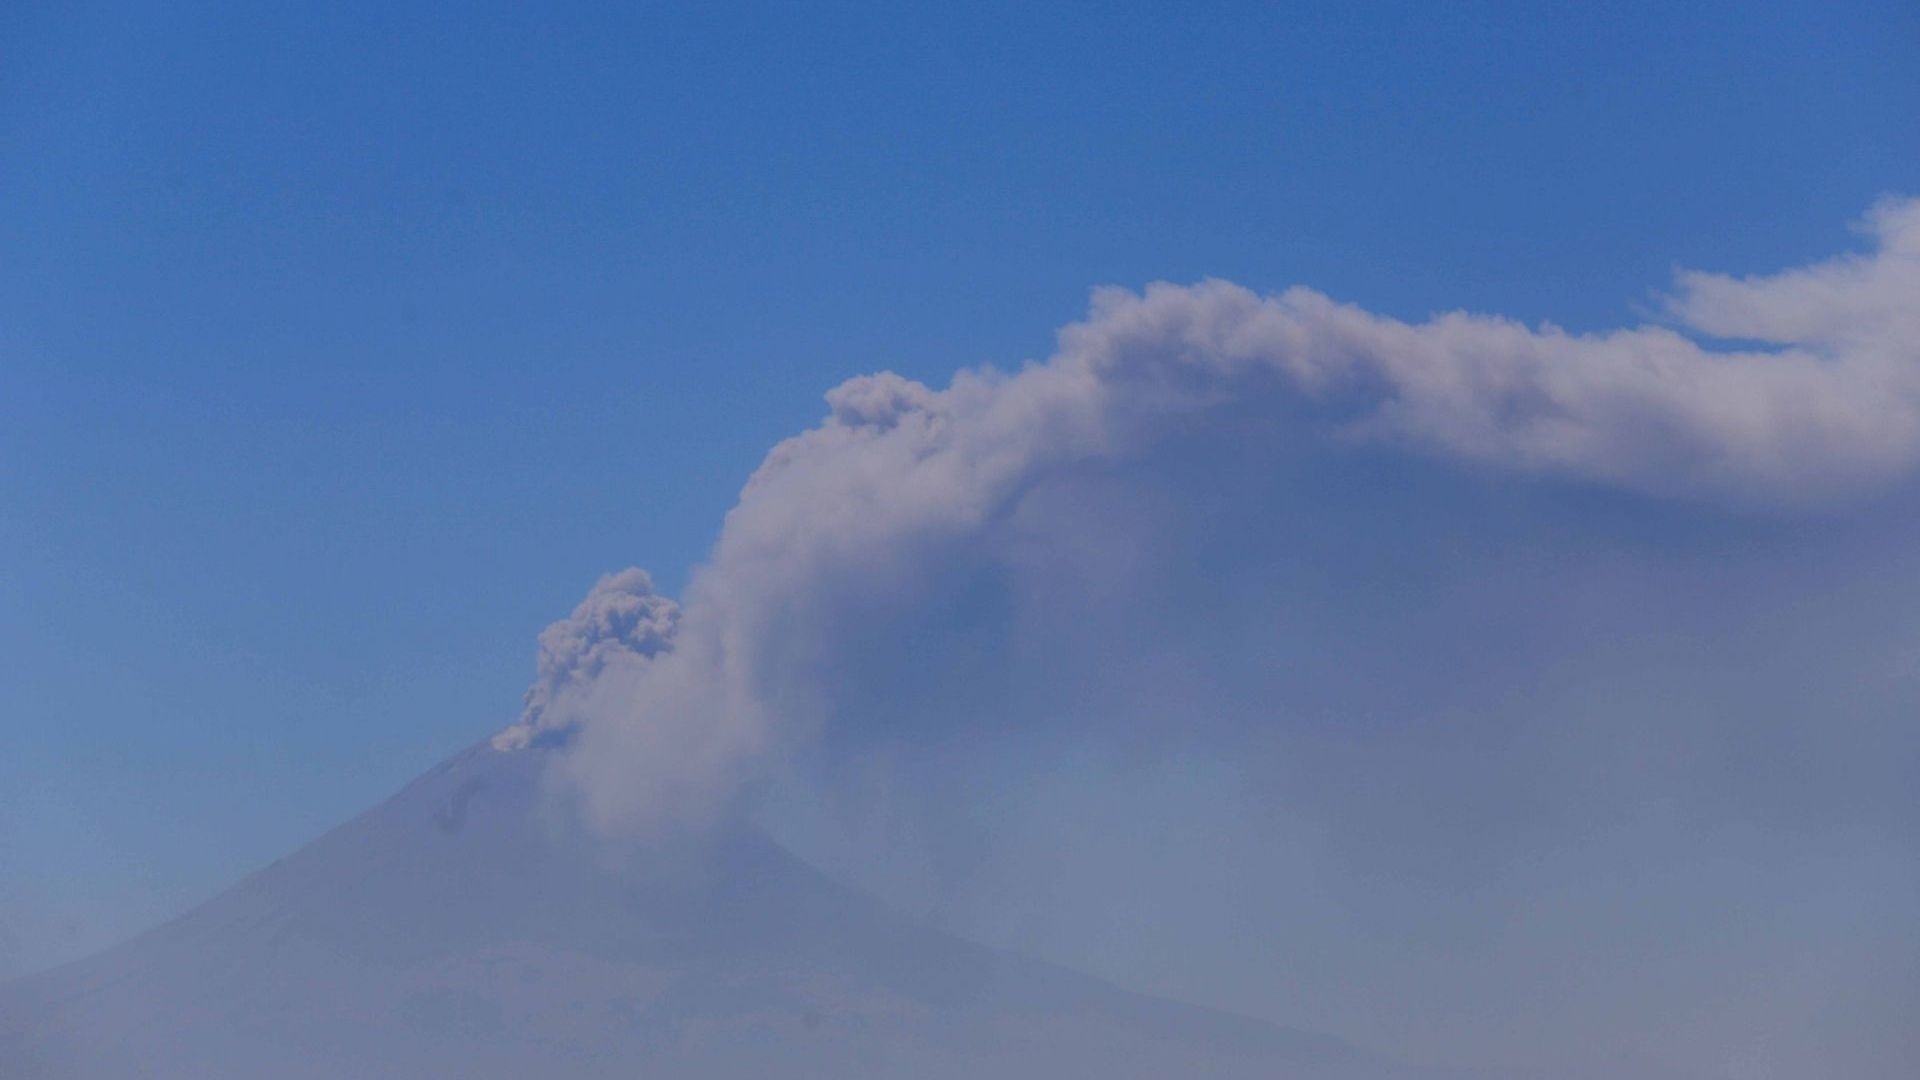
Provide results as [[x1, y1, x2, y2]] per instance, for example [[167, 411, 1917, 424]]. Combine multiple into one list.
[[503, 200, 1920, 832]]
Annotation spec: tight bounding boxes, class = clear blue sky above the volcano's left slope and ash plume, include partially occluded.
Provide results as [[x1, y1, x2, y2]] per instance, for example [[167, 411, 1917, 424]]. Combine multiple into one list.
[[0, 0, 1920, 972]]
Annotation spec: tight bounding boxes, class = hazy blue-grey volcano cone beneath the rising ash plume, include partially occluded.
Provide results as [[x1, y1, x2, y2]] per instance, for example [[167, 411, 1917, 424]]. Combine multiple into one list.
[[0, 744, 1407, 1080]]
